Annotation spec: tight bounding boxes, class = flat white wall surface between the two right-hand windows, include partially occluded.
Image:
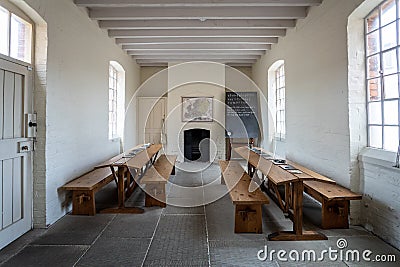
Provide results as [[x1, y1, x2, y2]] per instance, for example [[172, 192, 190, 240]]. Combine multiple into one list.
[[253, 0, 361, 192]]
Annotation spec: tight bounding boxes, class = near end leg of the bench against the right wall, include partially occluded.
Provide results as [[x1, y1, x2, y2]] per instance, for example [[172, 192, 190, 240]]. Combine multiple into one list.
[[321, 199, 350, 229]]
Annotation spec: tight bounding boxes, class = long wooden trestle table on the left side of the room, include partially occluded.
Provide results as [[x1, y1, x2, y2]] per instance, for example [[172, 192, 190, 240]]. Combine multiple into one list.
[[95, 144, 162, 213]]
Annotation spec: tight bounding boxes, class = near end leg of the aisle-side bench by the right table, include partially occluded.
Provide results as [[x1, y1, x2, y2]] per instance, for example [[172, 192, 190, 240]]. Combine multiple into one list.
[[235, 205, 262, 234]]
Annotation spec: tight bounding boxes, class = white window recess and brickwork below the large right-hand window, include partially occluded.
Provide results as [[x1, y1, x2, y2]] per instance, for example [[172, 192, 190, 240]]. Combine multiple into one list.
[[348, 0, 400, 248]]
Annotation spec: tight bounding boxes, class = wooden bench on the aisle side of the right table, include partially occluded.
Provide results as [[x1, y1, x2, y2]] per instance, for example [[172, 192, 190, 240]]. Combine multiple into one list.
[[219, 161, 269, 234]]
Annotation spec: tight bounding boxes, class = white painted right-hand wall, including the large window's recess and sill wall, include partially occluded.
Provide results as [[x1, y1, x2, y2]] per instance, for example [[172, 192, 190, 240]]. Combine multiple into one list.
[[253, 0, 400, 248]]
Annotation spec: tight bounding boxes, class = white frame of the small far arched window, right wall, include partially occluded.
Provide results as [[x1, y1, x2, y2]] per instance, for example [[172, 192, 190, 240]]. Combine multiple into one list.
[[274, 63, 286, 141]]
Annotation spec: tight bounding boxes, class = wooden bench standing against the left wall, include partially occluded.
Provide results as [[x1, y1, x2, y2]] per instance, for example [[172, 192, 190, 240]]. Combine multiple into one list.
[[61, 168, 114, 216]]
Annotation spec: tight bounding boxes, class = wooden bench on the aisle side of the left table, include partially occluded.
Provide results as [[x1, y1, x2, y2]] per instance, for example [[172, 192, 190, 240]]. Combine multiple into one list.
[[140, 155, 177, 208]]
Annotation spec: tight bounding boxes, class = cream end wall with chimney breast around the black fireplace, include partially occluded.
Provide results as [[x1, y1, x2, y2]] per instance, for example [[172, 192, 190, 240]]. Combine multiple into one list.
[[137, 62, 262, 161]]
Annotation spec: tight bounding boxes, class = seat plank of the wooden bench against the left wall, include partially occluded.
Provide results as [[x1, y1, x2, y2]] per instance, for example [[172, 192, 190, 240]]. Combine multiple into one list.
[[61, 168, 114, 191]]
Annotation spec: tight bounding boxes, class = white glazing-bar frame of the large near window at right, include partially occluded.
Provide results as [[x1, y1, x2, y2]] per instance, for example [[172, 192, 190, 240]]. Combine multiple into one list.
[[363, 0, 400, 151]]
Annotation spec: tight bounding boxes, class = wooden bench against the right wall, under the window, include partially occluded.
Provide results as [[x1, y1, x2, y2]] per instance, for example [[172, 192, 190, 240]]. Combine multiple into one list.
[[304, 181, 362, 229]]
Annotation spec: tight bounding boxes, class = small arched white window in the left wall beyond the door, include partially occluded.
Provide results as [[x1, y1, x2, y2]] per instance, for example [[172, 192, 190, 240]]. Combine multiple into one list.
[[108, 61, 125, 140]]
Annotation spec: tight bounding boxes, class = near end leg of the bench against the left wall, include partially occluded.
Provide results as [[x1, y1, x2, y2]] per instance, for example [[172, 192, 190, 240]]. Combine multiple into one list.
[[72, 190, 96, 216]]
